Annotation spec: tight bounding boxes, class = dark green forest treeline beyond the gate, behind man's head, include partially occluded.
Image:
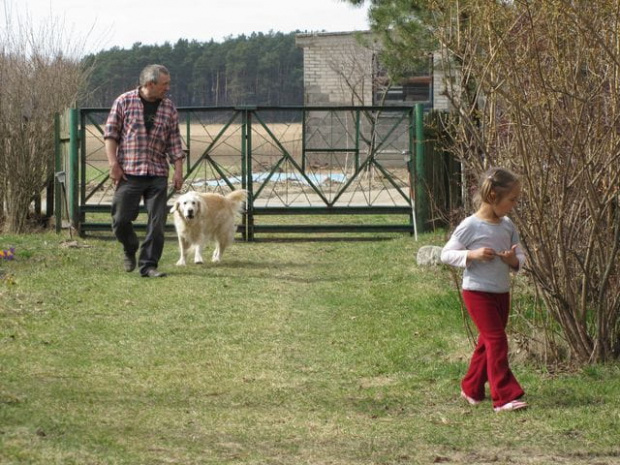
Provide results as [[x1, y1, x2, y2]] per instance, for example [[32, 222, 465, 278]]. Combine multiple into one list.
[[79, 32, 303, 108]]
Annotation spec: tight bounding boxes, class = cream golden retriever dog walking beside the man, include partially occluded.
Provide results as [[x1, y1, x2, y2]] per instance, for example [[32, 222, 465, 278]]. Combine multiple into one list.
[[170, 189, 247, 266]]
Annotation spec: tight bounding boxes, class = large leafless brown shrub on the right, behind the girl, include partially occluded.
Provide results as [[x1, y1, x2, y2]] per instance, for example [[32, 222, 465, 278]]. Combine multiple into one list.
[[433, 0, 620, 363]]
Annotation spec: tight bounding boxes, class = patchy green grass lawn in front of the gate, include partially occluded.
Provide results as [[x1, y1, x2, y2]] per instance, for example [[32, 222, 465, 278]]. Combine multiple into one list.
[[0, 233, 620, 465]]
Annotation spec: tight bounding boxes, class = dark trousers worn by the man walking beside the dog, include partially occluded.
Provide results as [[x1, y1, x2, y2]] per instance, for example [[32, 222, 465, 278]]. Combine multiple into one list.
[[112, 176, 168, 275]]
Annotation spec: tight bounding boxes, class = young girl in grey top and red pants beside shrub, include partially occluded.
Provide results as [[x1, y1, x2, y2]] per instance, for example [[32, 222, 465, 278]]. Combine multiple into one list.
[[441, 168, 527, 412]]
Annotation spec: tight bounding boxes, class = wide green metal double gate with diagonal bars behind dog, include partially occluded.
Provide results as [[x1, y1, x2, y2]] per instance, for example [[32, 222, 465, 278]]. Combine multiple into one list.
[[55, 105, 440, 240]]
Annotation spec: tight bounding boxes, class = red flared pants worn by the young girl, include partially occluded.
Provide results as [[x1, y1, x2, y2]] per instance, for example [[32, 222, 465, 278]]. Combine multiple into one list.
[[461, 291, 524, 407]]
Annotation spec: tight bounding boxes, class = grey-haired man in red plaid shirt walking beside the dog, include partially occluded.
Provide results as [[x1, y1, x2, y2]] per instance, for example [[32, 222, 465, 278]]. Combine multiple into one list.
[[103, 65, 185, 278]]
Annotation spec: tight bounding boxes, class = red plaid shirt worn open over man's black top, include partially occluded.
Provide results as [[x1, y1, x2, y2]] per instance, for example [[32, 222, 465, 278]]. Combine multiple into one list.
[[103, 89, 185, 176]]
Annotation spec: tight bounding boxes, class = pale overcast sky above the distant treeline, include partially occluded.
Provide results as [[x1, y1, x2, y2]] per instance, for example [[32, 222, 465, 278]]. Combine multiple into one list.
[[8, 0, 368, 53]]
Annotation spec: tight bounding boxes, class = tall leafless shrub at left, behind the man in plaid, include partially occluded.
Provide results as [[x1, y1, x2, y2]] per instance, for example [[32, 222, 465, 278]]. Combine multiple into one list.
[[0, 3, 87, 233]]
